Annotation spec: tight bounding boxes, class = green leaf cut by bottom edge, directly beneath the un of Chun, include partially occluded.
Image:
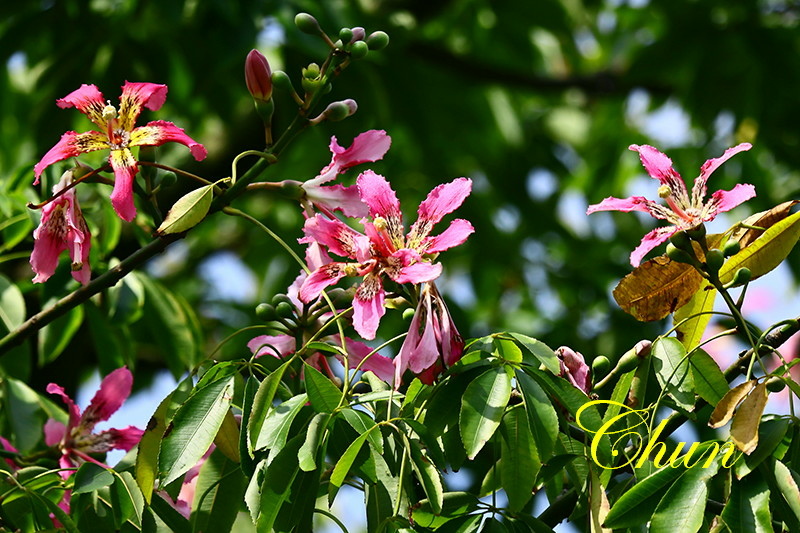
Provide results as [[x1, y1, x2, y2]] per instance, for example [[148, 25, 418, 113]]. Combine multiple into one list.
[[650, 458, 724, 533]]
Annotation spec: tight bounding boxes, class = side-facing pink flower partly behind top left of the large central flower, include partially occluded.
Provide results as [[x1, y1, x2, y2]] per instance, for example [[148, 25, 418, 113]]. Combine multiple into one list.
[[302, 130, 392, 217]]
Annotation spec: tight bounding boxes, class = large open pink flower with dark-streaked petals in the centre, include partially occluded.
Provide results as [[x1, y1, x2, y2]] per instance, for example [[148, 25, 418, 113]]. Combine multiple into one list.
[[300, 170, 474, 339]]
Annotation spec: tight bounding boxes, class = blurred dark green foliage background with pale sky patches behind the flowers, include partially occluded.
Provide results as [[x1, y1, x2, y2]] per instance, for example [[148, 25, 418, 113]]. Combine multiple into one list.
[[0, 0, 800, 389]]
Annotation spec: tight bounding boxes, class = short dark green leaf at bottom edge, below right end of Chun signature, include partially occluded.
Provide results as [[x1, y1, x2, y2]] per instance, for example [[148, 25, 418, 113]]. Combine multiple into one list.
[[720, 470, 773, 533]]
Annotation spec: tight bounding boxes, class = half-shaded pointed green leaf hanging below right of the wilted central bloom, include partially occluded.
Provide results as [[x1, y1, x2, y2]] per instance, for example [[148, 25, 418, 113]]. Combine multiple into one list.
[[459, 366, 513, 459]]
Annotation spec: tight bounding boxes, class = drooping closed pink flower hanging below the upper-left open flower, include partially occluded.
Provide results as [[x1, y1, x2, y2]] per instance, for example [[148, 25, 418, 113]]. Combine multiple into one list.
[[31, 170, 92, 285]]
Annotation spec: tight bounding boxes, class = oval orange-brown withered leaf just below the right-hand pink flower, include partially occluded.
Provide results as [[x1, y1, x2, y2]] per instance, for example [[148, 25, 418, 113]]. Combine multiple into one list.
[[614, 256, 703, 322]]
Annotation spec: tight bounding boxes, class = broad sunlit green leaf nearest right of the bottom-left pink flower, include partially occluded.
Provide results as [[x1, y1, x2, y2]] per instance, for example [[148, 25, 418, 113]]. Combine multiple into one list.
[[158, 376, 234, 486]]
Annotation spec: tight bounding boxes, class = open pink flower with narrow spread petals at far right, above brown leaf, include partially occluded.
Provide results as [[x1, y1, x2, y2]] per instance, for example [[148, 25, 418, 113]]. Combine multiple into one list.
[[586, 143, 756, 267]]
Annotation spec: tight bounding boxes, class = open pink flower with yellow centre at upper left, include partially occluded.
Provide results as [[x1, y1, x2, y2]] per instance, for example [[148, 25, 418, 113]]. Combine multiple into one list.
[[33, 81, 206, 221]]
